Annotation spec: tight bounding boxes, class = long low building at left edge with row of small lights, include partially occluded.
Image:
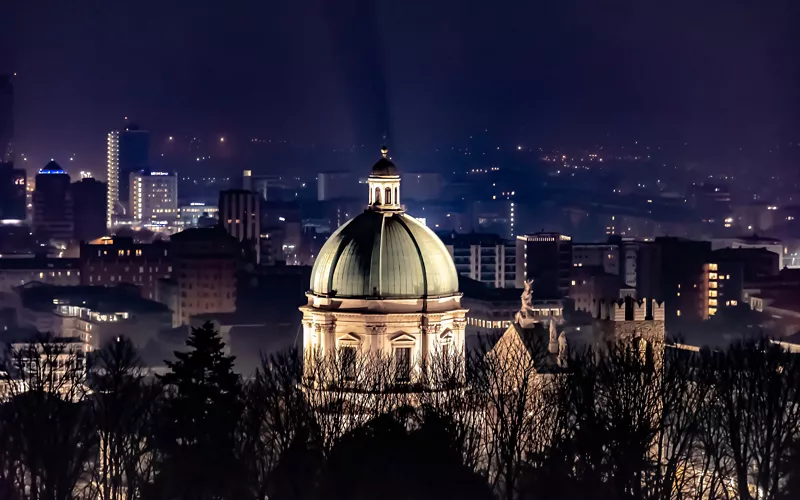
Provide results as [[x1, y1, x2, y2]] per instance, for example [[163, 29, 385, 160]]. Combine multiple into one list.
[[0, 255, 81, 295]]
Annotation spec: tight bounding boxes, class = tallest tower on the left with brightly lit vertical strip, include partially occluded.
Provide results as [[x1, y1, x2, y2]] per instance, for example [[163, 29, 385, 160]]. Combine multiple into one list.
[[107, 124, 150, 227]]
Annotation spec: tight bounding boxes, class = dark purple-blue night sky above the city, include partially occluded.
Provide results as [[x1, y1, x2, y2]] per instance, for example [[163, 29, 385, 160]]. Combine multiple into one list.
[[0, 0, 800, 170]]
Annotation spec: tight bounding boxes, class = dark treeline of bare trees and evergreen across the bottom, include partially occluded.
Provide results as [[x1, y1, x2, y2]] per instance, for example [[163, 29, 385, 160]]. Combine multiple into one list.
[[0, 324, 800, 500]]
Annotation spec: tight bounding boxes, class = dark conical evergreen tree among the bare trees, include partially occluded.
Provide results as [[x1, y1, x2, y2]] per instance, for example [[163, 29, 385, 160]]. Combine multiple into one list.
[[156, 322, 243, 500]]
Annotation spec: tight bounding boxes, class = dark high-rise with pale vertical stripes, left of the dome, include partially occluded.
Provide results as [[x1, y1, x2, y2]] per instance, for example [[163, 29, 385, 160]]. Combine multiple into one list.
[[219, 189, 261, 263]]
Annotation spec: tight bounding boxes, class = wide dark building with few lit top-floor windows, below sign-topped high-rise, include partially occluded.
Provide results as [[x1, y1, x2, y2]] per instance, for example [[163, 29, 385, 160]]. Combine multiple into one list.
[[80, 236, 172, 300]]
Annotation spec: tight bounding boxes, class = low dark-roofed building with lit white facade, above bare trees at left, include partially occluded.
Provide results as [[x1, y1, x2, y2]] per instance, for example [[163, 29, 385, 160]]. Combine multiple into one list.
[[11, 283, 171, 350]]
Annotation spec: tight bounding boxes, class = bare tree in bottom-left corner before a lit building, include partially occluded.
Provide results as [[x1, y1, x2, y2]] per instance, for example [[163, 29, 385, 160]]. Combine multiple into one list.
[[0, 335, 97, 500]]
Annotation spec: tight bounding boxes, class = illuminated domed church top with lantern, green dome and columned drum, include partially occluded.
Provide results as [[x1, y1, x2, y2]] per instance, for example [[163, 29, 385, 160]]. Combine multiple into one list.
[[300, 148, 467, 382]]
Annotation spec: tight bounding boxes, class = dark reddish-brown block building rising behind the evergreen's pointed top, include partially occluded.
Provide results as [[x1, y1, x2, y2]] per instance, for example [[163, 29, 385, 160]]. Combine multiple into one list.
[[167, 227, 242, 325]]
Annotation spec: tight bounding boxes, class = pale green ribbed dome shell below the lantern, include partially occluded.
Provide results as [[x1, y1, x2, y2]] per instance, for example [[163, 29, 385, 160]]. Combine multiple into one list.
[[311, 210, 458, 298]]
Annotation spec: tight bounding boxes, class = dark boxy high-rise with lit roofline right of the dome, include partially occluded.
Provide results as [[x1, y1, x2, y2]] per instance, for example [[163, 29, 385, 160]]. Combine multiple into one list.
[[517, 233, 572, 298]]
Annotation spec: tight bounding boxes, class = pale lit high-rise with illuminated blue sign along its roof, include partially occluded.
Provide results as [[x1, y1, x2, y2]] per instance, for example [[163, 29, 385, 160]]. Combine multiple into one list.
[[130, 170, 178, 223]]
